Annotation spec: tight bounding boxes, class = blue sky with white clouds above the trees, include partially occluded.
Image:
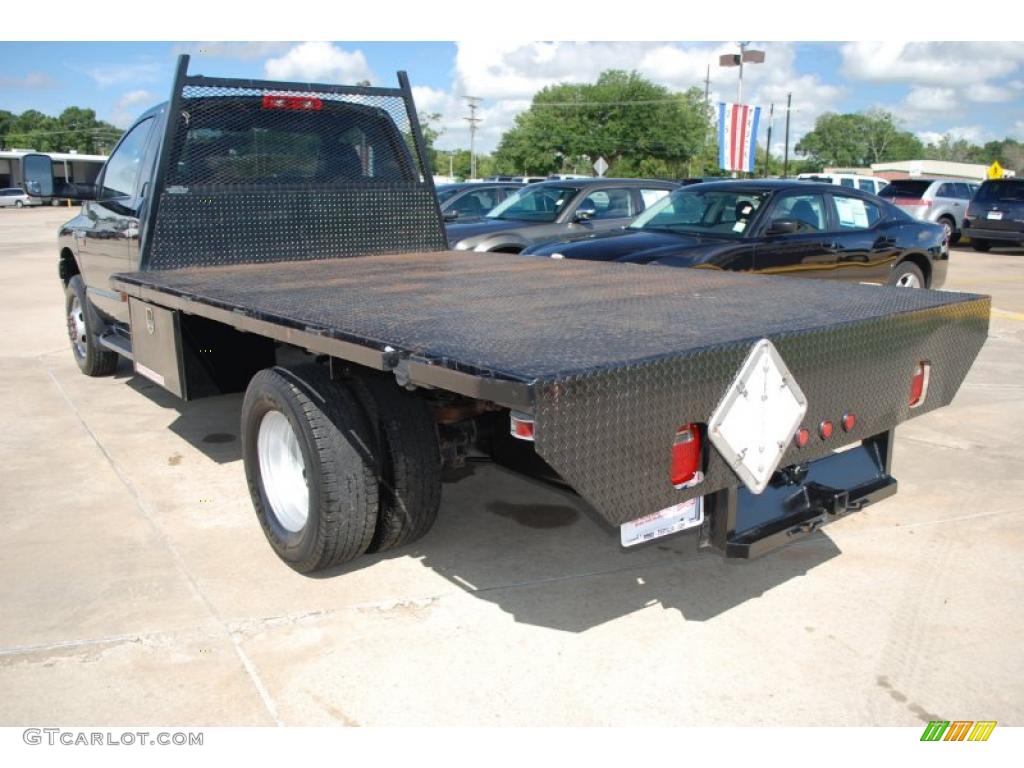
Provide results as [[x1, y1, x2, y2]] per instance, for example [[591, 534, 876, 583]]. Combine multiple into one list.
[[0, 39, 1024, 159]]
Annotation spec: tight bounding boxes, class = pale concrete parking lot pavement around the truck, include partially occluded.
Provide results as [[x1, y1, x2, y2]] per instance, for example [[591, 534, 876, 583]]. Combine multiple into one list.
[[0, 209, 1024, 725]]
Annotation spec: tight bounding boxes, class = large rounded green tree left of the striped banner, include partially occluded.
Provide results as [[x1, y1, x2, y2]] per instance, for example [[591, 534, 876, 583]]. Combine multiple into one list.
[[495, 70, 710, 176]]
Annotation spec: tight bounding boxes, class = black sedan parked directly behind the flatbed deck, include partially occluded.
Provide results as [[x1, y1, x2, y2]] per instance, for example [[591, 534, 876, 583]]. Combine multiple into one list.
[[523, 179, 949, 288]]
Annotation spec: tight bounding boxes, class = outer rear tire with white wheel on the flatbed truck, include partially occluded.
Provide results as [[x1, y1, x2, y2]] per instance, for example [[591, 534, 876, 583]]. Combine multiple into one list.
[[242, 365, 378, 573]]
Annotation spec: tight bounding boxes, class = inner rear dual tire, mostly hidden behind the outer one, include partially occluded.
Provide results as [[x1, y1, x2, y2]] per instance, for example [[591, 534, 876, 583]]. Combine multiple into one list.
[[350, 376, 441, 552]]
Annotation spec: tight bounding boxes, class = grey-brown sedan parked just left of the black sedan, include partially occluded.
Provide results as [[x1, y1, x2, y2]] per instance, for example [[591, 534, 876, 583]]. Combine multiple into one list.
[[445, 178, 678, 253]]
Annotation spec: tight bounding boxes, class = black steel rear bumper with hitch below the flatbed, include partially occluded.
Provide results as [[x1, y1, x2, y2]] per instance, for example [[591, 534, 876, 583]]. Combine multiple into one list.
[[702, 430, 896, 559]]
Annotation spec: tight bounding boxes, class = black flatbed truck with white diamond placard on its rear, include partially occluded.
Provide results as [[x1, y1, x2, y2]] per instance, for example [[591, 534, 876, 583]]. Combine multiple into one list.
[[26, 57, 989, 571]]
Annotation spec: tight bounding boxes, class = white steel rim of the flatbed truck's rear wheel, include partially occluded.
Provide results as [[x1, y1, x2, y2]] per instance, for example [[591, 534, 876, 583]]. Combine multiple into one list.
[[256, 411, 309, 534]]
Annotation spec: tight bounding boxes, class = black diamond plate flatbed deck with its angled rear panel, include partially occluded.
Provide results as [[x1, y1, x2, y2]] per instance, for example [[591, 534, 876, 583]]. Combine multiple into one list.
[[120, 252, 989, 524]]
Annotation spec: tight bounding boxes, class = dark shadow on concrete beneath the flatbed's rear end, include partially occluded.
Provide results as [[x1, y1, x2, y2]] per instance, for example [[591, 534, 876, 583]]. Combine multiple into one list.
[[319, 465, 840, 632]]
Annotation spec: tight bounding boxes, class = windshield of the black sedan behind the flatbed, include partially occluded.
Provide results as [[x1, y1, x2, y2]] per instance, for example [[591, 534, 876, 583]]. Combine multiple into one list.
[[630, 186, 768, 238]]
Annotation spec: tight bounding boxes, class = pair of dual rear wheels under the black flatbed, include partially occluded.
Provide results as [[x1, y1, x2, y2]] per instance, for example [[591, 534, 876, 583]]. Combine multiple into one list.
[[242, 365, 441, 573]]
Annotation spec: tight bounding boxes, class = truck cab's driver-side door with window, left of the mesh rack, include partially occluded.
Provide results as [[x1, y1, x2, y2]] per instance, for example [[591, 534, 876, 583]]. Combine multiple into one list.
[[78, 117, 154, 323]]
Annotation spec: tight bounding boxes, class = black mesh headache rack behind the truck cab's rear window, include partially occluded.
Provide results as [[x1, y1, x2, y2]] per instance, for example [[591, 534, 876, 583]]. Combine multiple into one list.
[[141, 56, 446, 269]]
